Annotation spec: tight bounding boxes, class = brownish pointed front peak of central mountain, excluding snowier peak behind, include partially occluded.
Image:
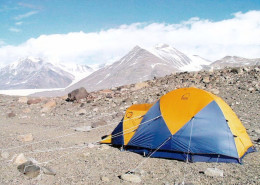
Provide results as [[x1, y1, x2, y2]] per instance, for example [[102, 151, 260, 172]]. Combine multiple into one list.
[[66, 46, 181, 91]]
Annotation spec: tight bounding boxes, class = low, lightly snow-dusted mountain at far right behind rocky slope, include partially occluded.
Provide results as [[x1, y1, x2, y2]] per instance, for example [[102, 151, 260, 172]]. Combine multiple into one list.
[[211, 56, 260, 69]]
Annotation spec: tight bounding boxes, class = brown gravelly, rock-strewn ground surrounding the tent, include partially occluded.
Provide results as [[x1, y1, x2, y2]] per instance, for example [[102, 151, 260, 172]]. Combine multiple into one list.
[[0, 66, 260, 184]]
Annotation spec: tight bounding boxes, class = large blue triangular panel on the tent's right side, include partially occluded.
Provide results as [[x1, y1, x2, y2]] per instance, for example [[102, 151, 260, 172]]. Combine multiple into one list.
[[161, 101, 238, 158]]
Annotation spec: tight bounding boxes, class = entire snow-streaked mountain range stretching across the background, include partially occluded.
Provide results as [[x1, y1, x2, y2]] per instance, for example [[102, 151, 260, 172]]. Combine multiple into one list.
[[0, 44, 260, 95]]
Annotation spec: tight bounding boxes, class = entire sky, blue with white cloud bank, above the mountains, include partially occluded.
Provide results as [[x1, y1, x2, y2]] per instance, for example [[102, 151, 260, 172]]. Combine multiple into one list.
[[0, 0, 260, 66]]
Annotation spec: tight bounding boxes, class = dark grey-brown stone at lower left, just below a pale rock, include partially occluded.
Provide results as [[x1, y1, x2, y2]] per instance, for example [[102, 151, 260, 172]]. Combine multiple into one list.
[[17, 161, 41, 178]]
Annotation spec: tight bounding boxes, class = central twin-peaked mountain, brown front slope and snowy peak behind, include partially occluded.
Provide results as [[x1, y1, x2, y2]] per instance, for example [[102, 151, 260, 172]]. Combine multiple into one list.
[[65, 44, 210, 91]]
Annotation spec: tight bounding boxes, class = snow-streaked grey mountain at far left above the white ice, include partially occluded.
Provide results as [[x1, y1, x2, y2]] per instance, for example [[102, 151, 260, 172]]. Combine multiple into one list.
[[0, 57, 91, 89]]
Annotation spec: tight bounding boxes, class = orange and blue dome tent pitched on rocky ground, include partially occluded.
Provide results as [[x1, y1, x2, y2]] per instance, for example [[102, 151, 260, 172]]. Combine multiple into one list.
[[101, 88, 254, 163]]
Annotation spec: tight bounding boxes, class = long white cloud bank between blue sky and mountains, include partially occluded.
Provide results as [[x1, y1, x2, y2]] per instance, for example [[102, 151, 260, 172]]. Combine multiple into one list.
[[0, 11, 260, 64]]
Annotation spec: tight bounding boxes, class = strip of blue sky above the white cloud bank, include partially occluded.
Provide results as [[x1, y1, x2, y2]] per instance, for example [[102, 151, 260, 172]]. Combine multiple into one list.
[[0, 0, 260, 45]]
